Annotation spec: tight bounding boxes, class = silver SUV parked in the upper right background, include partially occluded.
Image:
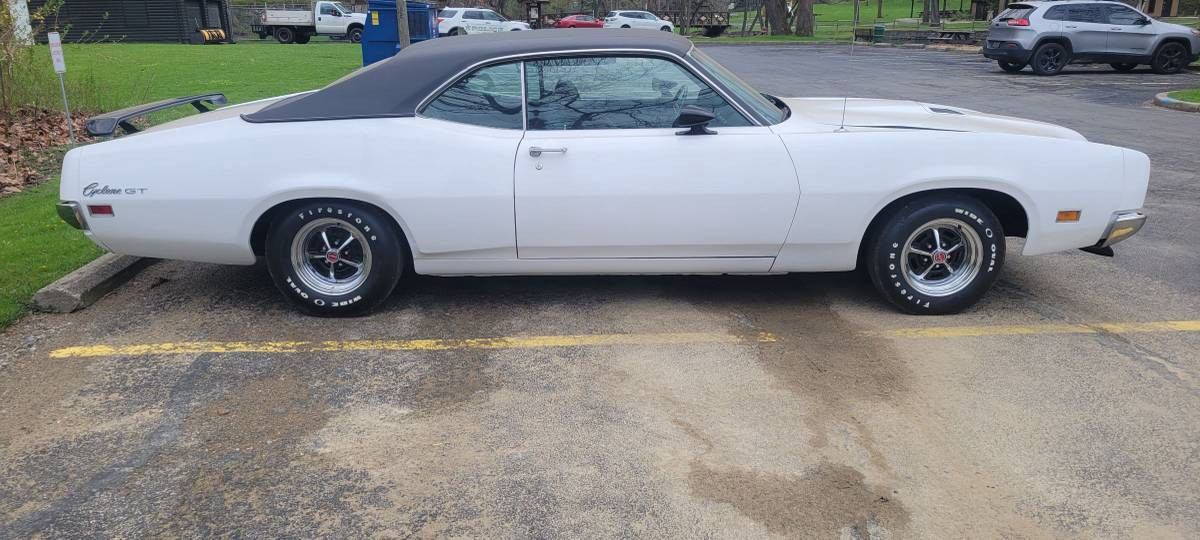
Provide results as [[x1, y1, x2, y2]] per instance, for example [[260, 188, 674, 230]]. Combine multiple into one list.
[[983, 0, 1200, 74]]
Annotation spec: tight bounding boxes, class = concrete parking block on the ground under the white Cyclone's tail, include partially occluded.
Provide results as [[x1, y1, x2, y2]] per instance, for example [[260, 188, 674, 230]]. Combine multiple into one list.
[[34, 253, 158, 313]]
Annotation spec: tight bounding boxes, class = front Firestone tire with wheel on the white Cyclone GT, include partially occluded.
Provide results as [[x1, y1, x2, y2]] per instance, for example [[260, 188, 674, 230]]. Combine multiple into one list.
[[864, 196, 1004, 314]]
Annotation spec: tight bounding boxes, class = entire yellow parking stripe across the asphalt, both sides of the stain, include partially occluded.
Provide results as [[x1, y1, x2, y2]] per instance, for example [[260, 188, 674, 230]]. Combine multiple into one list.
[[50, 320, 1200, 358]]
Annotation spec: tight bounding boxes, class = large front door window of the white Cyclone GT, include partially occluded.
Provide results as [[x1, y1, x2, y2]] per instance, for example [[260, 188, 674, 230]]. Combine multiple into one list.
[[526, 56, 750, 130]]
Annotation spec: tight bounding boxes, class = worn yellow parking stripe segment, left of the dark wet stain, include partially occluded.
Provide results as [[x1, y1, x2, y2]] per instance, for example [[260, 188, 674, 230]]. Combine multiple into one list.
[[50, 332, 776, 358]]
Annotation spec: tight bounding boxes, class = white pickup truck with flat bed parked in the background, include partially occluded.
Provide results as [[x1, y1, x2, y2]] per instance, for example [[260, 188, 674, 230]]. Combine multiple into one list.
[[251, 1, 367, 43]]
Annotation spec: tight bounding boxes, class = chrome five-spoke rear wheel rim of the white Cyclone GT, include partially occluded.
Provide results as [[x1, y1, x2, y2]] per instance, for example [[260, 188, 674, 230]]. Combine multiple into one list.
[[292, 217, 371, 296]]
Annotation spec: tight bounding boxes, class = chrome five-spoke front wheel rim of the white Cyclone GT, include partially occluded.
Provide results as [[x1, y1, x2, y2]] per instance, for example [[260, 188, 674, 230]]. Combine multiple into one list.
[[900, 218, 983, 296]]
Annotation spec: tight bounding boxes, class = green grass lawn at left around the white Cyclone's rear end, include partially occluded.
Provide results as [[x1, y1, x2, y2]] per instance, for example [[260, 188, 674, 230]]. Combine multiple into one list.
[[0, 42, 361, 328]]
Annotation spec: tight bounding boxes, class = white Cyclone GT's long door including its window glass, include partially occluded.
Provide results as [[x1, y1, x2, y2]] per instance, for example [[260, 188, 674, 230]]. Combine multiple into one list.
[[515, 55, 799, 265]]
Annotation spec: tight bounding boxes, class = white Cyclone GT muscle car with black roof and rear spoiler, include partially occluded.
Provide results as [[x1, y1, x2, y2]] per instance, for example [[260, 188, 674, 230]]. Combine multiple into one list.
[[59, 30, 1150, 316]]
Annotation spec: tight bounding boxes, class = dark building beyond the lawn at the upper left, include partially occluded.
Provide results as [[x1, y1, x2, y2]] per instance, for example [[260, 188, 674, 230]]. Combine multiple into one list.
[[28, 0, 232, 43]]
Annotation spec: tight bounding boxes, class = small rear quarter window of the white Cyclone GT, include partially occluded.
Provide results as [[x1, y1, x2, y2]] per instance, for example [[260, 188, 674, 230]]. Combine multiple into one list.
[[421, 62, 521, 130]]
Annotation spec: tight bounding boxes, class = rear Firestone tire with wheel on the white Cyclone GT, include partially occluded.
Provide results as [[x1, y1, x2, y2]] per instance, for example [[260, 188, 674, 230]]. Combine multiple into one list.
[[265, 200, 406, 317]]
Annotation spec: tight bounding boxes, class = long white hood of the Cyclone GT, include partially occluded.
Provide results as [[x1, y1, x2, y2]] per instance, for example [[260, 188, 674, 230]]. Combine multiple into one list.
[[784, 97, 1087, 140]]
